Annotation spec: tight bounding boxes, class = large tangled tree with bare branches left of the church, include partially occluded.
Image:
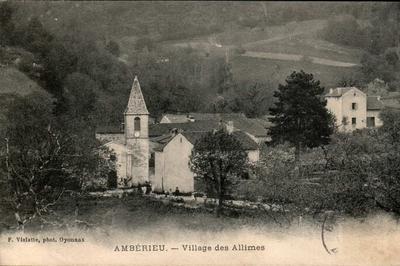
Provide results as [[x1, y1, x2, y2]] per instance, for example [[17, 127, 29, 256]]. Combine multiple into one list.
[[0, 93, 113, 229]]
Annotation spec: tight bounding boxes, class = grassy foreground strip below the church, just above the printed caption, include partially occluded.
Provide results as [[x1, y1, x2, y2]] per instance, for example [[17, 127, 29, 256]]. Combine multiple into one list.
[[0, 194, 306, 234]]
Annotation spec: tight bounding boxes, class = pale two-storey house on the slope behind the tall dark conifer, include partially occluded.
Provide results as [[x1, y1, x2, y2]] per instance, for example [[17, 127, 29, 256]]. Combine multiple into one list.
[[325, 87, 384, 132]]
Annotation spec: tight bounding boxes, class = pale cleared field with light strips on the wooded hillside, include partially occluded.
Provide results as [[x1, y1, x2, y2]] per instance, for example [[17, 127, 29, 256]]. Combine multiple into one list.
[[164, 20, 362, 87]]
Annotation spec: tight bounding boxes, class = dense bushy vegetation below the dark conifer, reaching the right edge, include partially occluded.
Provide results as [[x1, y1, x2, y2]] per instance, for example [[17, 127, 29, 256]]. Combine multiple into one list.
[[235, 110, 400, 216]]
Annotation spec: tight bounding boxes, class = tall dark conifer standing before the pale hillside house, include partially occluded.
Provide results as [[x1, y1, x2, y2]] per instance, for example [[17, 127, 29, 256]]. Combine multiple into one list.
[[270, 71, 334, 162]]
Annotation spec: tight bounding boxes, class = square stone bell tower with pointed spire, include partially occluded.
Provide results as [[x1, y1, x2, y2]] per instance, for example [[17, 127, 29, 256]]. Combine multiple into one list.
[[124, 77, 149, 185]]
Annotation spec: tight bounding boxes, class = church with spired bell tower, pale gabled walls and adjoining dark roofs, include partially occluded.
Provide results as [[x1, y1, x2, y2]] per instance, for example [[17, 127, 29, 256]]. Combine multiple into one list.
[[96, 77, 268, 192]]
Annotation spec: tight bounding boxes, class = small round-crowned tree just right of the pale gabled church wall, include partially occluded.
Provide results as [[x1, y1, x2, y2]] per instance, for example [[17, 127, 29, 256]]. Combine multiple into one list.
[[189, 129, 248, 216]]
